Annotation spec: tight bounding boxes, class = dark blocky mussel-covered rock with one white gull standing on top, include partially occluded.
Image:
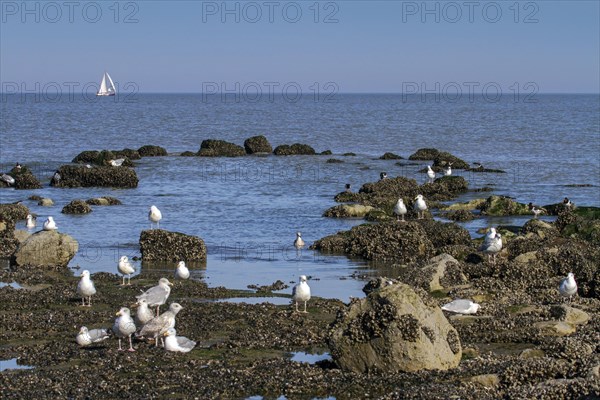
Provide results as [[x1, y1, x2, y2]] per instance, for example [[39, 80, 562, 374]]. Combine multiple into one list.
[[140, 229, 206, 262]]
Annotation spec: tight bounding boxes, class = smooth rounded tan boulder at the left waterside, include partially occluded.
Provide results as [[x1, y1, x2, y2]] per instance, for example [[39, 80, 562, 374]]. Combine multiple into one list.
[[15, 231, 79, 266]]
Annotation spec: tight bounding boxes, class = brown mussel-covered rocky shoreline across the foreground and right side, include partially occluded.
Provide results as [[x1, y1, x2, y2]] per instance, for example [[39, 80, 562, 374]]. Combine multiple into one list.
[[0, 145, 600, 399]]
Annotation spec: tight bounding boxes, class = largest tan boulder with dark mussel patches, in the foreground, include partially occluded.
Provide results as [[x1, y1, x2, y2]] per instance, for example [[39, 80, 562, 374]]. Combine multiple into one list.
[[328, 278, 462, 373]]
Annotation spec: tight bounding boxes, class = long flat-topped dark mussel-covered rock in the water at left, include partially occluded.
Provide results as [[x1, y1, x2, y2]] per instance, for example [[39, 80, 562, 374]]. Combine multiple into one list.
[[51, 165, 139, 188]]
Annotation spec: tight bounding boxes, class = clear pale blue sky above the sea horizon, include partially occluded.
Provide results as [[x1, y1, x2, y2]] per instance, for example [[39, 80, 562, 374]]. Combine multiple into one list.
[[0, 0, 600, 93]]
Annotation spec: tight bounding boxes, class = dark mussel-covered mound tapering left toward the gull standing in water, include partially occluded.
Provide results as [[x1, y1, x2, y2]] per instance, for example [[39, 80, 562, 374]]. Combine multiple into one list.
[[311, 221, 435, 263]]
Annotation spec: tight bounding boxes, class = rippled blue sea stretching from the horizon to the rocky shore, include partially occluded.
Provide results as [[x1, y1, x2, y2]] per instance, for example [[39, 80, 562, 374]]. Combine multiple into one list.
[[0, 94, 600, 300]]
